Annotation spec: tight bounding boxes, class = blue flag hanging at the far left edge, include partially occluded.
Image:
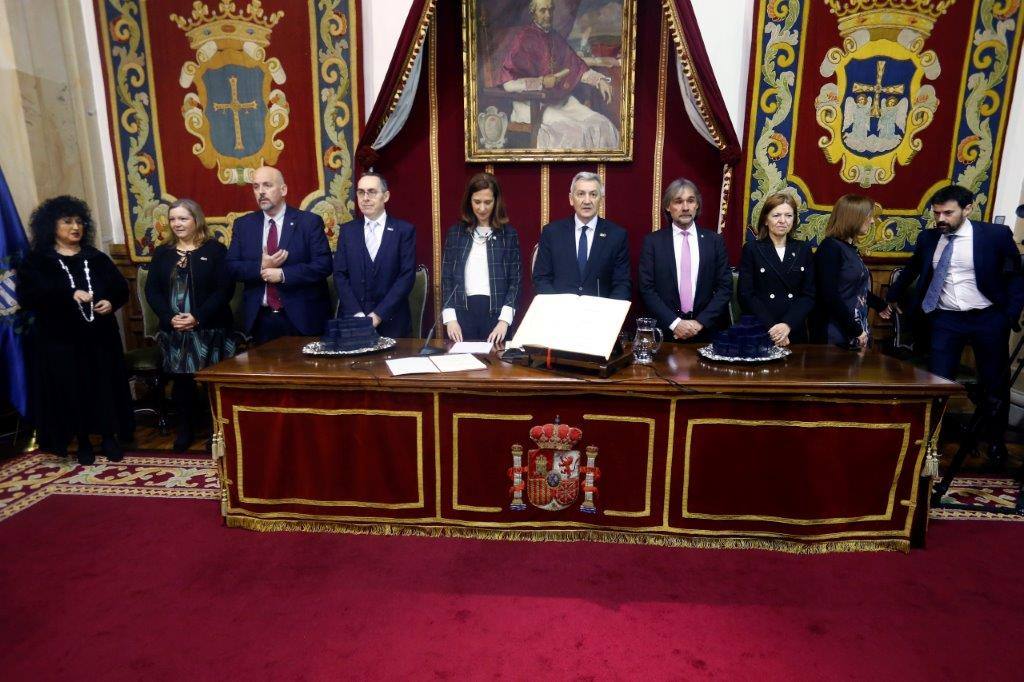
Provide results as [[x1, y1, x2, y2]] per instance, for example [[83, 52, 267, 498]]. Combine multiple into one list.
[[0, 168, 29, 415]]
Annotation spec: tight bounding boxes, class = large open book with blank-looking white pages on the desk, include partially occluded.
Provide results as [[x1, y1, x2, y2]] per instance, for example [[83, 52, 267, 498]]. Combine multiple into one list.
[[508, 294, 630, 359]]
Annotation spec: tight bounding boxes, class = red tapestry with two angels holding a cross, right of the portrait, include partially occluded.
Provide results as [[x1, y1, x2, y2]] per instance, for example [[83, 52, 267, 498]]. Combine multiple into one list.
[[743, 0, 1024, 255]]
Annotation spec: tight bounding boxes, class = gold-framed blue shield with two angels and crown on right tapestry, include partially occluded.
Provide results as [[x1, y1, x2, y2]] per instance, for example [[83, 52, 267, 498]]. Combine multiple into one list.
[[814, 0, 955, 187]]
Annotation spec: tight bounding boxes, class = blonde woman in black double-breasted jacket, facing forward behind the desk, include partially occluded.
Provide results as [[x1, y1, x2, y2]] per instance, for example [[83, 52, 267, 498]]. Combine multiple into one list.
[[737, 191, 814, 347]]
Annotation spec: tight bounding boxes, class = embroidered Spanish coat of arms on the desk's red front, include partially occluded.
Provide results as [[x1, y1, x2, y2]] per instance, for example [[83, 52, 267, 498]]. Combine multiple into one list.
[[508, 417, 601, 514]]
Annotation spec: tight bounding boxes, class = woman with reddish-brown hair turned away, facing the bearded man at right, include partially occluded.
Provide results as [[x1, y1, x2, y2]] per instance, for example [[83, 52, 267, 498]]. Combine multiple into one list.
[[812, 195, 885, 349]]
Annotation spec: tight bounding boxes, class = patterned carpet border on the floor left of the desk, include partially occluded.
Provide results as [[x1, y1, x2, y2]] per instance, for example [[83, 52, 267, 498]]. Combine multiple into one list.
[[0, 453, 220, 521]]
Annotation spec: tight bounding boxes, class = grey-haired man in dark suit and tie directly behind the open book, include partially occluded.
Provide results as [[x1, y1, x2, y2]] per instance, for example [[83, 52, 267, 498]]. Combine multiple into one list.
[[534, 173, 630, 301]]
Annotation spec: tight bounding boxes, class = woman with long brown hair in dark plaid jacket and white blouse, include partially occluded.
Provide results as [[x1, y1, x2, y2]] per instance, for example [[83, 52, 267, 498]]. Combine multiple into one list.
[[441, 173, 521, 345]]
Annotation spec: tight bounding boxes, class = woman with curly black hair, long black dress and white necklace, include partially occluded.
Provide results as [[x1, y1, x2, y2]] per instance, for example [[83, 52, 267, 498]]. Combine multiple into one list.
[[17, 196, 135, 464]]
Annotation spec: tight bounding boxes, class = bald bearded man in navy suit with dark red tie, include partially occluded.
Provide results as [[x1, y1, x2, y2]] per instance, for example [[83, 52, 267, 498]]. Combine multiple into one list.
[[227, 166, 331, 344]]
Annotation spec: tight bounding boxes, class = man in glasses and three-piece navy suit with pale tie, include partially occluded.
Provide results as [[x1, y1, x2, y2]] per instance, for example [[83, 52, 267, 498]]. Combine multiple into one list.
[[334, 171, 416, 338]]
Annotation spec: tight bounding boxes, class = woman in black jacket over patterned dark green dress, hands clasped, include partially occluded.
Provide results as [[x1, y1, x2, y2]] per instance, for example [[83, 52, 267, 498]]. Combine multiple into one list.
[[145, 199, 234, 453]]
